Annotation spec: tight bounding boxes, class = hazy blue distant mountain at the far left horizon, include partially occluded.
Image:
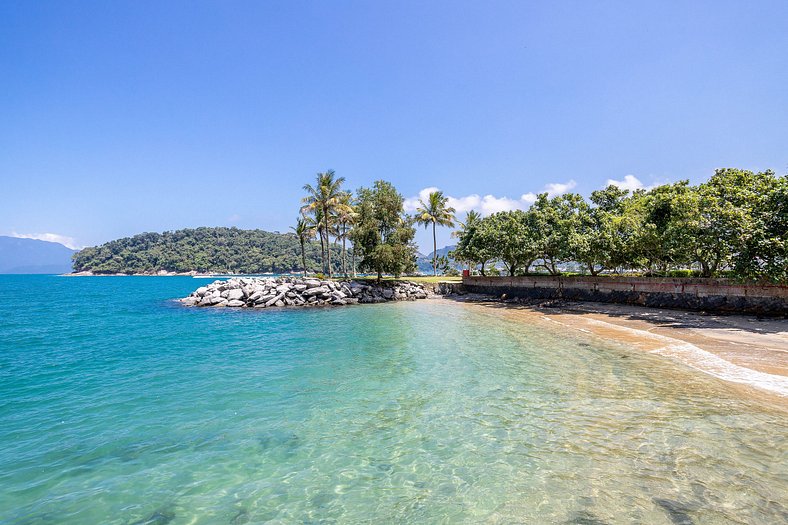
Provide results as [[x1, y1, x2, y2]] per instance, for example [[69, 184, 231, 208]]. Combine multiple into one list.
[[0, 235, 75, 273]]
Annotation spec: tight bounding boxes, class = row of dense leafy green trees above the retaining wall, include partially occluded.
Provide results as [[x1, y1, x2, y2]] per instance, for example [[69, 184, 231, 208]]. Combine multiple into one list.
[[454, 168, 788, 283]]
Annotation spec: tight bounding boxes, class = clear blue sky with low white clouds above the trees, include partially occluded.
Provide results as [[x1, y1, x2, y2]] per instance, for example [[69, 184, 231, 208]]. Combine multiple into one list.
[[0, 0, 788, 252]]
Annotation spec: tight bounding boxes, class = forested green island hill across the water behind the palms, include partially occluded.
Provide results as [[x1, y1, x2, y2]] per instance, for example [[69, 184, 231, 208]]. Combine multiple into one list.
[[74, 227, 341, 273]]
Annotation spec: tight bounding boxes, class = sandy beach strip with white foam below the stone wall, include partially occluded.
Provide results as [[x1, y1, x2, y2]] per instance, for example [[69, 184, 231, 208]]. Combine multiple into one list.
[[444, 296, 788, 402]]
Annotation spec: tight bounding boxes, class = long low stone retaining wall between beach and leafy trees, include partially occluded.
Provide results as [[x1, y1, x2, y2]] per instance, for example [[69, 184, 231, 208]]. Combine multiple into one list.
[[462, 275, 788, 316]]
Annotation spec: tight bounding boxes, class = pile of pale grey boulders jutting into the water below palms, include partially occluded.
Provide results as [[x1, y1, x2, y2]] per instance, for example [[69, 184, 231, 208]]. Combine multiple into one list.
[[180, 277, 429, 308]]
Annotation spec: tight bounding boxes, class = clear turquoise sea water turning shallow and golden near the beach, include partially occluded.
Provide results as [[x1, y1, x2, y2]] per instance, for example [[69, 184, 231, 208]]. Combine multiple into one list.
[[0, 276, 788, 525]]
